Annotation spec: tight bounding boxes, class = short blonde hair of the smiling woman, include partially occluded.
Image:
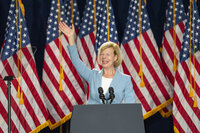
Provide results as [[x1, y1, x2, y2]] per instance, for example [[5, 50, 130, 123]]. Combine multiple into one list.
[[98, 42, 122, 67]]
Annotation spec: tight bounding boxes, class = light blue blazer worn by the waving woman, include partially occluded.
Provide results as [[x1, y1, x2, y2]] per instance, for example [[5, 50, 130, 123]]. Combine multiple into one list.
[[67, 44, 135, 104]]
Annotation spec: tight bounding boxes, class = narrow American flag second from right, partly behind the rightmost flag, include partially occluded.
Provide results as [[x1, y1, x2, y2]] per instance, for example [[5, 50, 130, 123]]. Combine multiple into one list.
[[160, 0, 186, 116]]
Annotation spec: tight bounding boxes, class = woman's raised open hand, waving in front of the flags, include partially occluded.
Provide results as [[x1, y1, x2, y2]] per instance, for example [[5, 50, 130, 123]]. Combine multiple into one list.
[[59, 22, 75, 46]]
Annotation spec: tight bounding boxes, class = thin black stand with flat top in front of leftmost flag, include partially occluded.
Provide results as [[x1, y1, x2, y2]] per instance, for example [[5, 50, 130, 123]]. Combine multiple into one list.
[[3, 76, 13, 133]]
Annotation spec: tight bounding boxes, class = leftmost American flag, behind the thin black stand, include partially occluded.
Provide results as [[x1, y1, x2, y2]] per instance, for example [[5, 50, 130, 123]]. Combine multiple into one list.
[[0, 0, 48, 133]]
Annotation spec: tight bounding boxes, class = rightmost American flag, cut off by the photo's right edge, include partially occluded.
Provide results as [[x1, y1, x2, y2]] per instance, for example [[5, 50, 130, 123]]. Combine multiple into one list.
[[173, 0, 200, 133]]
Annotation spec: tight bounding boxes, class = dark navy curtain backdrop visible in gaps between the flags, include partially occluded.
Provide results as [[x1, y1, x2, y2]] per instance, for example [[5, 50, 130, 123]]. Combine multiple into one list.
[[0, 0, 199, 133]]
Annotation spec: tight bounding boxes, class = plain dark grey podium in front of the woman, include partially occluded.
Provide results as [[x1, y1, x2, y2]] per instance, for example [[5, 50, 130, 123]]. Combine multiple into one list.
[[70, 104, 145, 133]]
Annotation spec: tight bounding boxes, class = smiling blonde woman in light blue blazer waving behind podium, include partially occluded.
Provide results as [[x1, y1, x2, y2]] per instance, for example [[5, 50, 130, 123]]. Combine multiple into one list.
[[59, 22, 135, 104]]
